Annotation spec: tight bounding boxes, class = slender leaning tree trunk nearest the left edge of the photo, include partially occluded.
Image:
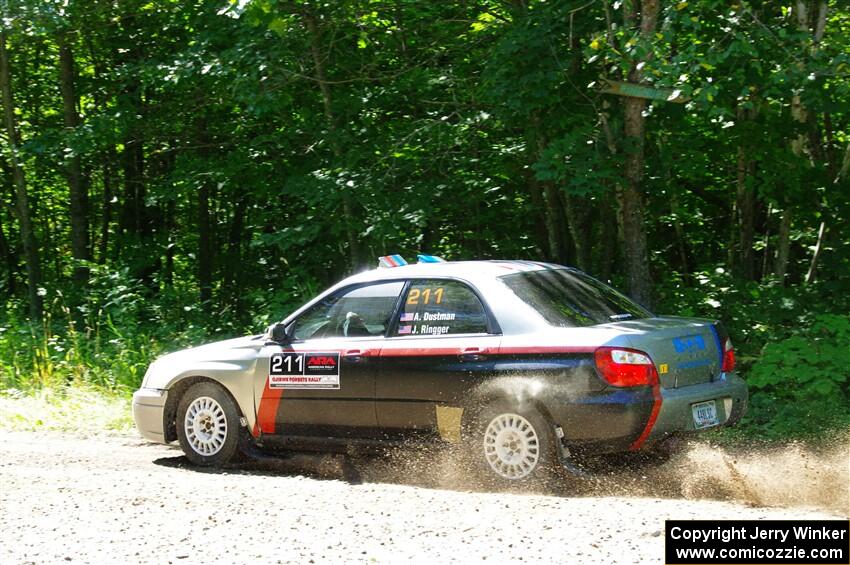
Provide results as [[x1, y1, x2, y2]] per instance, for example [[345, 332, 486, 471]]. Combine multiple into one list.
[[0, 31, 42, 320]]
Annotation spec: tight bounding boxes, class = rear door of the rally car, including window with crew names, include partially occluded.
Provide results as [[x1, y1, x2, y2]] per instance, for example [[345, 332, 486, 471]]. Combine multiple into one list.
[[375, 279, 501, 435]]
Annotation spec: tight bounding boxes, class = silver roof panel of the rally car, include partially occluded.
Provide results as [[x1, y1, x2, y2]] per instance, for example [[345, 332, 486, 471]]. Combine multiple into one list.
[[340, 260, 564, 285]]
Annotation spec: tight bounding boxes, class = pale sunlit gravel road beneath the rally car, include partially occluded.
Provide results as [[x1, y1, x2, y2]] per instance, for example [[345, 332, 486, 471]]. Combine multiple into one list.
[[0, 432, 850, 565]]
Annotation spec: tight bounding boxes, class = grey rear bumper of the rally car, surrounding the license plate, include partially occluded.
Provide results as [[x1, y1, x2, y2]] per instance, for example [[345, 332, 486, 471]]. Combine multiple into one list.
[[646, 373, 748, 444]]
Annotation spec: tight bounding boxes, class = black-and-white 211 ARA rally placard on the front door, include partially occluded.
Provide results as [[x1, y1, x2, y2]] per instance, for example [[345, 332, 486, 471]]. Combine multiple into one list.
[[269, 351, 339, 389]]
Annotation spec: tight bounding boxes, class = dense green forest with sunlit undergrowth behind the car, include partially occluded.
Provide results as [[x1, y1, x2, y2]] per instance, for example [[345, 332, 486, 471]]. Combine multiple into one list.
[[0, 0, 850, 438]]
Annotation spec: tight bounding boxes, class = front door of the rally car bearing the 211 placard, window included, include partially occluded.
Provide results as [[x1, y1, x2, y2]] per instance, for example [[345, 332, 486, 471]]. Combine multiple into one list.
[[255, 282, 404, 437]]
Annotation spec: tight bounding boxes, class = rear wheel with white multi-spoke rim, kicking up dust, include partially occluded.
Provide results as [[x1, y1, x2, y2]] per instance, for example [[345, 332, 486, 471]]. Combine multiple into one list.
[[464, 401, 563, 487]]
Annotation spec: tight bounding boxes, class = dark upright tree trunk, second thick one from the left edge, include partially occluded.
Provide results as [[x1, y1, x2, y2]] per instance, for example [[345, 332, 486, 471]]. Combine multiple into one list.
[[58, 34, 91, 287]]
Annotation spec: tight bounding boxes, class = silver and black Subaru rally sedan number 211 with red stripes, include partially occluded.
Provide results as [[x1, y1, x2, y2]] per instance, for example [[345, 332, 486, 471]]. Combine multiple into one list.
[[133, 256, 747, 482]]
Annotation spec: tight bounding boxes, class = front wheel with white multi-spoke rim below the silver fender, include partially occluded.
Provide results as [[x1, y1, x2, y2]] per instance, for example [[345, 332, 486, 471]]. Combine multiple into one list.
[[176, 382, 240, 467]]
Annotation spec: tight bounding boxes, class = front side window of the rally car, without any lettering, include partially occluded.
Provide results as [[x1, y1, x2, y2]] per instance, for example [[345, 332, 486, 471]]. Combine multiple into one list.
[[292, 282, 404, 341]]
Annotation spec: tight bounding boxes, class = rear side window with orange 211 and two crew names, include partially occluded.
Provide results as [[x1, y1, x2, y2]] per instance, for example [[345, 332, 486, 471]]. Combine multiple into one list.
[[395, 279, 487, 336]]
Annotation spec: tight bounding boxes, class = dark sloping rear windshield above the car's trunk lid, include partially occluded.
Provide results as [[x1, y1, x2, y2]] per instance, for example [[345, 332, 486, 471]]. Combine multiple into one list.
[[500, 269, 652, 327]]
